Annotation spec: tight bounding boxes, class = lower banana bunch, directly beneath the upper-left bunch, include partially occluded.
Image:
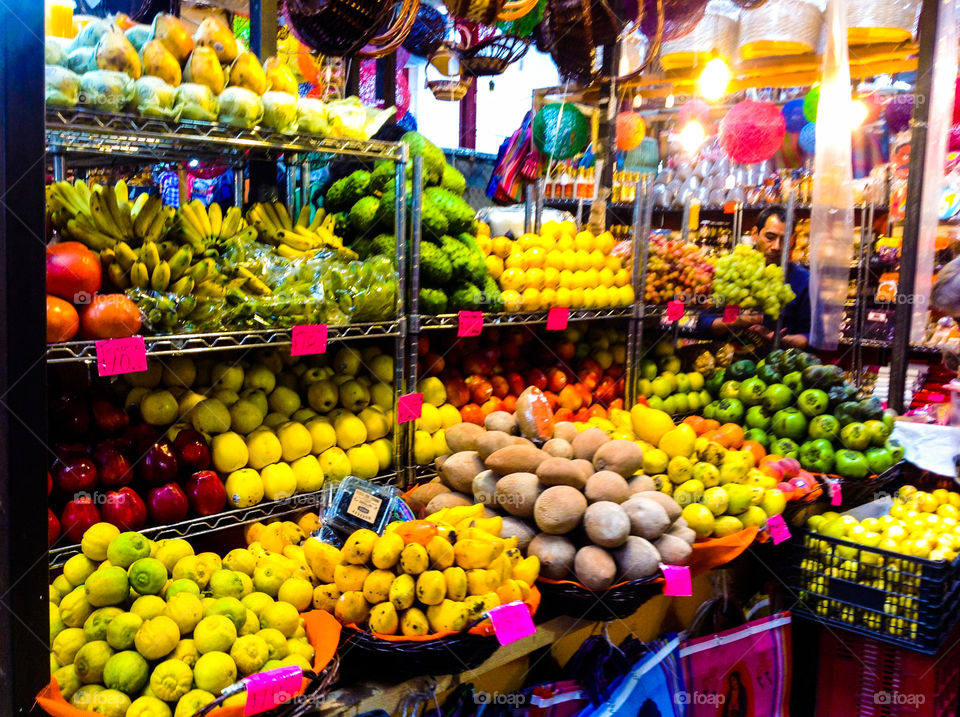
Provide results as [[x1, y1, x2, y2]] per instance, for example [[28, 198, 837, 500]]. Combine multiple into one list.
[[100, 241, 217, 296]]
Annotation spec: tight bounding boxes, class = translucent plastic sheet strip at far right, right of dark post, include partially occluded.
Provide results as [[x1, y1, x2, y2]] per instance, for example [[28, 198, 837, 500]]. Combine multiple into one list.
[[908, 0, 957, 343]]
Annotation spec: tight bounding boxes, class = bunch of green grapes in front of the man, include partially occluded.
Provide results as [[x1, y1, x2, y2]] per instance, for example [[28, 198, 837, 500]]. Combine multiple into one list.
[[713, 244, 795, 319]]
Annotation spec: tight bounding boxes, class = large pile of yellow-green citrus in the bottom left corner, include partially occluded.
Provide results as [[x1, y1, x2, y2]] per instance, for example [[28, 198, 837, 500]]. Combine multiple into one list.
[[50, 523, 314, 717]]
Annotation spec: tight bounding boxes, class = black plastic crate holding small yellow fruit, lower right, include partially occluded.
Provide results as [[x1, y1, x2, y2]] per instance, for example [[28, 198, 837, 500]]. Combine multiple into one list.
[[787, 530, 960, 654]]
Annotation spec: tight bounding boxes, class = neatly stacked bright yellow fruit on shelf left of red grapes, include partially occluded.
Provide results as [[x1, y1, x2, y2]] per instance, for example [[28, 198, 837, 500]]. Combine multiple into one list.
[[477, 221, 634, 312]]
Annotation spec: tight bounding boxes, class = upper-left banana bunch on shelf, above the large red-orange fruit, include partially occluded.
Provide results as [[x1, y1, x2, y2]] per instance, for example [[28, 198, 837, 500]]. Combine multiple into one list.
[[47, 179, 174, 251]]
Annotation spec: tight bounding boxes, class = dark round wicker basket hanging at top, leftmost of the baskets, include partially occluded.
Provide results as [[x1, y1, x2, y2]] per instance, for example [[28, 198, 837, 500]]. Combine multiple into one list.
[[284, 0, 394, 57]]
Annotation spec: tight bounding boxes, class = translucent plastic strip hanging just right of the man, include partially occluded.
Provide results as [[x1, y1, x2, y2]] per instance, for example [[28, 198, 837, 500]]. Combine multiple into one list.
[[810, 0, 854, 350]]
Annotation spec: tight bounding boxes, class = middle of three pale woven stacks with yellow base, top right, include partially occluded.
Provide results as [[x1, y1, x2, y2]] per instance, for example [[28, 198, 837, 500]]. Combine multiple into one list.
[[738, 0, 823, 60]]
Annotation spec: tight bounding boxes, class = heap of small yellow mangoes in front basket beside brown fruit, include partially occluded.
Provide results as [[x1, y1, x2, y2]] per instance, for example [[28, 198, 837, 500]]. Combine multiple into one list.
[[303, 504, 540, 636]]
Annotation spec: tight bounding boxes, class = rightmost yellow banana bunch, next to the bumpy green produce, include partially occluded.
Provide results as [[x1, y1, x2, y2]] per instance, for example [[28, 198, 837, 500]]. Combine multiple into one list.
[[247, 202, 356, 259]]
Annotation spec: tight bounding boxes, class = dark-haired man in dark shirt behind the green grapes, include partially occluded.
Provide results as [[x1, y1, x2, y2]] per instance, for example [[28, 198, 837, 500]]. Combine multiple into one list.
[[702, 207, 810, 349]]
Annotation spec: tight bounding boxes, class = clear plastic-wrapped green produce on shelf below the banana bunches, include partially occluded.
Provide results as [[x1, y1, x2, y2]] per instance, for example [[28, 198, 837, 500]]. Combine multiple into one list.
[[127, 242, 397, 335]]
